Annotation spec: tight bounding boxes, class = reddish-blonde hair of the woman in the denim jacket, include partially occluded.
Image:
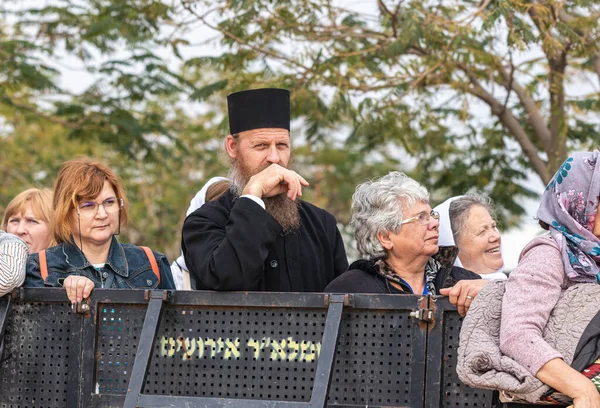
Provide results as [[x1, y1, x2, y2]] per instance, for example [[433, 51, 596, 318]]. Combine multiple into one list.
[[51, 157, 129, 244]]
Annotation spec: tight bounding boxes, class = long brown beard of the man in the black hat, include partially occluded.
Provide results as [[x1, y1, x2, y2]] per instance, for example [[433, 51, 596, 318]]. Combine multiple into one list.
[[229, 161, 300, 232]]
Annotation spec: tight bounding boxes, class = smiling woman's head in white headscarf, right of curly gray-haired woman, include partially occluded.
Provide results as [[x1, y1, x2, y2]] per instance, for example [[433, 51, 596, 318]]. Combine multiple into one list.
[[434, 192, 506, 280]]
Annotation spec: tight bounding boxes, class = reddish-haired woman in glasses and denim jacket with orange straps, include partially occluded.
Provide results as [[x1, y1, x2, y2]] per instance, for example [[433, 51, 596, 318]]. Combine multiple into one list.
[[25, 158, 175, 303]]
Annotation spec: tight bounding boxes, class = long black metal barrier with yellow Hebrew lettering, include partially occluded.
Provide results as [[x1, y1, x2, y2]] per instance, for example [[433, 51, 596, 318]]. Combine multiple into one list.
[[0, 289, 556, 408]]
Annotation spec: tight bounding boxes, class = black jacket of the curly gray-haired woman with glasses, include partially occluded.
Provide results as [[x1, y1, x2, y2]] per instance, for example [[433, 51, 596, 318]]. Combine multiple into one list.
[[325, 247, 481, 294]]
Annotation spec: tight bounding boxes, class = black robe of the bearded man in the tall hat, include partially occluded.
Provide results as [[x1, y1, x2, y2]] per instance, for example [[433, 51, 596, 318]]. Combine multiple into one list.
[[181, 191, 348, 292]]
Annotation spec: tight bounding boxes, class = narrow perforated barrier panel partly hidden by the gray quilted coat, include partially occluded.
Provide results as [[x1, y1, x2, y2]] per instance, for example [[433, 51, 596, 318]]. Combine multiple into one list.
[[439, 310, 493, 408]]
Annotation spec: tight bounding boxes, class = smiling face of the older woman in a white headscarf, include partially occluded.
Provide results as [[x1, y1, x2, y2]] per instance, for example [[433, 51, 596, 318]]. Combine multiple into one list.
[[458, 205, 504, 274]]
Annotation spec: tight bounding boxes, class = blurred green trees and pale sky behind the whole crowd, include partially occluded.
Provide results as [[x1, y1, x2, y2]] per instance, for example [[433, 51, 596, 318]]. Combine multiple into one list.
[[0, 0, 600, 258]]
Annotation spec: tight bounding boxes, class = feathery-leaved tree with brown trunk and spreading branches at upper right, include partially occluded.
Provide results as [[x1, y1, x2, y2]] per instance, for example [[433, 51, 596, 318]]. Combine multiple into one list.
[[180, 0, 600, 223]]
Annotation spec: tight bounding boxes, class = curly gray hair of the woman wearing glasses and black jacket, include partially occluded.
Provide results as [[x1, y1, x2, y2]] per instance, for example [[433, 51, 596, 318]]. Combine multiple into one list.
[[350, 171, 429, 259]]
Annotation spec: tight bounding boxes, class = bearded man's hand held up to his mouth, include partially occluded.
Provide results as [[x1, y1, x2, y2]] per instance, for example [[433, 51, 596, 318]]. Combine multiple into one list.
[[242, 164, 308, 200]]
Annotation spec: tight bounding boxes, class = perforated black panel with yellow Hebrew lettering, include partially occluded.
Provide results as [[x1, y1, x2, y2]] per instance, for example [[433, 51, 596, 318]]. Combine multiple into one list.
[[143, 307, 326, 401]]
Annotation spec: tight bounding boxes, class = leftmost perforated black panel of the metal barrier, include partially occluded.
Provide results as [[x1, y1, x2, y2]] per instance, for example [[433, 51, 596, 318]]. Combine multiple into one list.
[[0, 303, 80, 408]]
